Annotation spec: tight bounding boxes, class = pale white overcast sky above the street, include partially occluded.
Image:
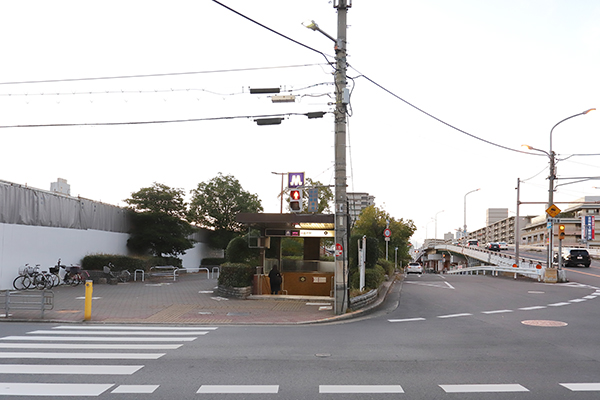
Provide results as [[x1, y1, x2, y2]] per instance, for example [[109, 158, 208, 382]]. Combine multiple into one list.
[[0, 0, 600, 245]]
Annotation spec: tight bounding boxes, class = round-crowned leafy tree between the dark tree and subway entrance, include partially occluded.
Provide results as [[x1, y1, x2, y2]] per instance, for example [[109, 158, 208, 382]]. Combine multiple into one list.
[[188, 172, 263, 248]]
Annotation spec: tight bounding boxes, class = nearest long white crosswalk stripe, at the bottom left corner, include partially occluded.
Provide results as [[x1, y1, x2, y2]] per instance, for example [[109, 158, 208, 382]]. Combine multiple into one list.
[[0, 382, 114, 397]]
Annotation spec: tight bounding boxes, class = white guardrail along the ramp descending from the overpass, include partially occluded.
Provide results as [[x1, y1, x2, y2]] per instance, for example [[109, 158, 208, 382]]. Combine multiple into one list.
[[435, 244, 544, 281]]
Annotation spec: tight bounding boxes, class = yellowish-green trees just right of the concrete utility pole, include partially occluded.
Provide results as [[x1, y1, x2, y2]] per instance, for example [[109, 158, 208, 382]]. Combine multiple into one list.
[[352, 206, 417, 264]]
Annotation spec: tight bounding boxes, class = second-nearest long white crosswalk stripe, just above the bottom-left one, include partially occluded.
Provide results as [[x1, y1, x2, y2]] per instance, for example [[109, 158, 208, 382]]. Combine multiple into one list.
[[0, 364, 144, 375]]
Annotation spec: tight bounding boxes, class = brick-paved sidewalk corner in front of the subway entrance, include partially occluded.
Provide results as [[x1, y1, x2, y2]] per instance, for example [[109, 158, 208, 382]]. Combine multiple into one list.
[[0, 273, 392, 325]]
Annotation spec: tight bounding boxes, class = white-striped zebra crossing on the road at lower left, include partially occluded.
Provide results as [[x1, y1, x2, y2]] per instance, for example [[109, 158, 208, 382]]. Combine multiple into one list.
[[0, 325, 217, 397]]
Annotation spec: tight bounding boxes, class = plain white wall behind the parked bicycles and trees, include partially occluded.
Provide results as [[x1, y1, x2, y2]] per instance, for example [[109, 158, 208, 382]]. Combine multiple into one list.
[[0, 224, 210, 290]]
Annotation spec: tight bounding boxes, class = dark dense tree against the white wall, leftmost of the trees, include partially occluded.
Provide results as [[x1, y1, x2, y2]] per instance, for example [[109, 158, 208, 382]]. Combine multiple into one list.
[[125, 182, 194, 257]]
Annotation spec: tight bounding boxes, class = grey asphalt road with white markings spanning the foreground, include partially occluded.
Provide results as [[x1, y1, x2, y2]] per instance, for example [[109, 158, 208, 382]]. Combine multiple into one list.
[[0, 267, 600, 400]]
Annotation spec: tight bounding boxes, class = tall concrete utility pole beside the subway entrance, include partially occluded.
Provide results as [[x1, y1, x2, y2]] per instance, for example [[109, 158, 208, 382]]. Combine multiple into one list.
[[333, 0, 352, 315]]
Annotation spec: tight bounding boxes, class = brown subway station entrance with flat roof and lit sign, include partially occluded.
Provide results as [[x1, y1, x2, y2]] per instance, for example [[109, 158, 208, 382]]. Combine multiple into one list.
[[236, 213, 335, 297]]
